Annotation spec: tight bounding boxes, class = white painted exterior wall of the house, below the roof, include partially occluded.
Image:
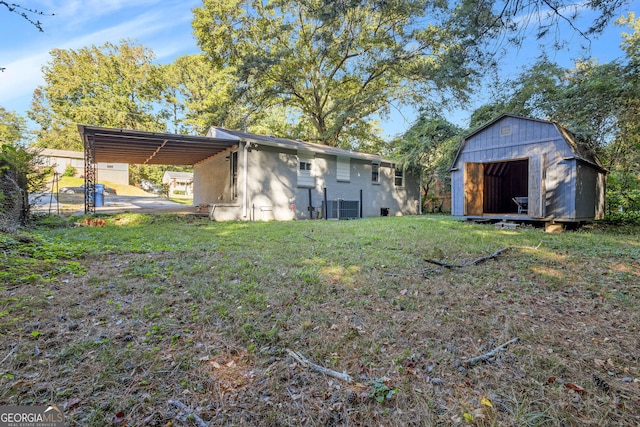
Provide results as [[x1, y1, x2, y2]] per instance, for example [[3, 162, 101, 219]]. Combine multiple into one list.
[[194, 143, 420, 220]]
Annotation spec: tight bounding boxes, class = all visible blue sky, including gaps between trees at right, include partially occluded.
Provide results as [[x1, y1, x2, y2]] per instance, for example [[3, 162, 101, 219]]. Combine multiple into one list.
[[0, 0, 640, 137]]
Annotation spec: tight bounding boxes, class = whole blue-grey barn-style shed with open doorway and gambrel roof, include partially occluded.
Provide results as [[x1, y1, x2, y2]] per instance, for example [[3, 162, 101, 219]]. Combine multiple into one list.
[[451, 114, 606, 223]]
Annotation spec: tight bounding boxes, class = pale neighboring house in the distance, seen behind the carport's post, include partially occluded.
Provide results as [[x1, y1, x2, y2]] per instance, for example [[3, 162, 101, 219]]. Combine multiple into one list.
[[40, 148, 129, 185]]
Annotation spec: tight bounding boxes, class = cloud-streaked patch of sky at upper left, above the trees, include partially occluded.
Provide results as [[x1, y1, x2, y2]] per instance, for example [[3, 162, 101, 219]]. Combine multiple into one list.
[[0, 0, 195, 114]]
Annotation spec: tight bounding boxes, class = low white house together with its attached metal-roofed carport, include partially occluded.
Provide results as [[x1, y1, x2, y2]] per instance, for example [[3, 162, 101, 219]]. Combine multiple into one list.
[[78, 125, 420, 220]]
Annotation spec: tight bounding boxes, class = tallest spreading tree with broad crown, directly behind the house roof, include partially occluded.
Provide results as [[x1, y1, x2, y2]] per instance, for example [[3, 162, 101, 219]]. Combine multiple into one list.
[[193, 0, 498, 149]]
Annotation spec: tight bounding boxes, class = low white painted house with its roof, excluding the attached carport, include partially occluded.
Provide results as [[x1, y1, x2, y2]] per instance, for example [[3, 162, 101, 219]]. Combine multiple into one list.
[[194, 128, 420, 220]]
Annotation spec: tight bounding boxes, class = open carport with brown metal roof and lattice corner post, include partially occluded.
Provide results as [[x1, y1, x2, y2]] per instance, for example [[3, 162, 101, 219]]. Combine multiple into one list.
[[78, 125, 238, 214]]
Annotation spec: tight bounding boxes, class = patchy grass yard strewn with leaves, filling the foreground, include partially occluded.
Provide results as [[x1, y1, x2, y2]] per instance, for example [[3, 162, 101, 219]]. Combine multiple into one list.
[[0, 219, 640, 426]]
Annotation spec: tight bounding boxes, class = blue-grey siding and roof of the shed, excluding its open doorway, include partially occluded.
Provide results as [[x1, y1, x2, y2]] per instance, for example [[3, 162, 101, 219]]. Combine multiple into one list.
[[451, 116, 605, 221]]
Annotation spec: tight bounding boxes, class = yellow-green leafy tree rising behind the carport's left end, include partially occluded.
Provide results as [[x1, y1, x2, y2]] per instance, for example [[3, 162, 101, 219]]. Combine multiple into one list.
[[29, 40, 165, 149]]
